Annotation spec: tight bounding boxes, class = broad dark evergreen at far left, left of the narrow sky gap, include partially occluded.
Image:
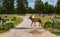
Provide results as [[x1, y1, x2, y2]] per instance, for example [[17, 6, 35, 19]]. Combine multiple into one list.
[[3, 0, 14, 14]]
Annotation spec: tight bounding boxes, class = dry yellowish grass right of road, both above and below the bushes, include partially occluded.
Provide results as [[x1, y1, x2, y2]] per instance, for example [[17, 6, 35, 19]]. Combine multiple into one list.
[[34, 14, 60, 35]]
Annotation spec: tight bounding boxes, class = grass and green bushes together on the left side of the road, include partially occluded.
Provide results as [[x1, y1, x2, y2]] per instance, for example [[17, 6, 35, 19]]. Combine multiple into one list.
[[0, 14, 23, 33]]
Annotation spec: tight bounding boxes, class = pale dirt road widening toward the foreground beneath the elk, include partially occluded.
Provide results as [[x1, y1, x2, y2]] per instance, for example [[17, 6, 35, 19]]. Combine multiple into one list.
[[0, 14, 60, 37]]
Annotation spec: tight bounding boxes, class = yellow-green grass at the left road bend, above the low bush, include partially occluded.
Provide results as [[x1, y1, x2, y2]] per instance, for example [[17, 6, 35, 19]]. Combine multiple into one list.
[[0, 14, 23, 24]]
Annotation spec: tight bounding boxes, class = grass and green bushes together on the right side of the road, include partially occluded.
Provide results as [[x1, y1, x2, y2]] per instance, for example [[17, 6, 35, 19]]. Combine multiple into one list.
[[35, 14, 60, 35]]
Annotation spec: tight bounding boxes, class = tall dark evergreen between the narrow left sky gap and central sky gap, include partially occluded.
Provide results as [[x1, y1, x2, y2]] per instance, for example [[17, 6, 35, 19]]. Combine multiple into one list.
[[17, 0, 28, 14]]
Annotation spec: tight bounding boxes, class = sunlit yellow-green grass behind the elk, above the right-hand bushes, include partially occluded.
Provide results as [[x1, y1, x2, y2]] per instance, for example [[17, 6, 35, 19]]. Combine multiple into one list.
[[34, 14, 60, 23]]
